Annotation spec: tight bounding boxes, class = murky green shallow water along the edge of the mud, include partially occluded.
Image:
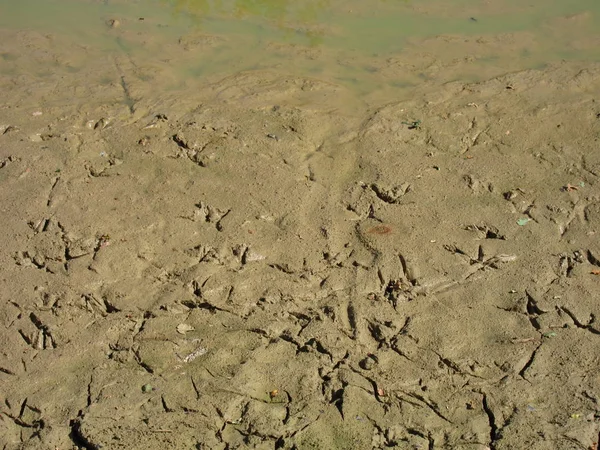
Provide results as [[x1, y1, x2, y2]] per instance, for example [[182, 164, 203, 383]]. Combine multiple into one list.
[[0, 0, 600, 99]]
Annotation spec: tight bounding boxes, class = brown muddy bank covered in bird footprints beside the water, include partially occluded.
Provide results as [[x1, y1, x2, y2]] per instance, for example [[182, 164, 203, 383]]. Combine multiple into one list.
[[0, 23, 600, 450]]
